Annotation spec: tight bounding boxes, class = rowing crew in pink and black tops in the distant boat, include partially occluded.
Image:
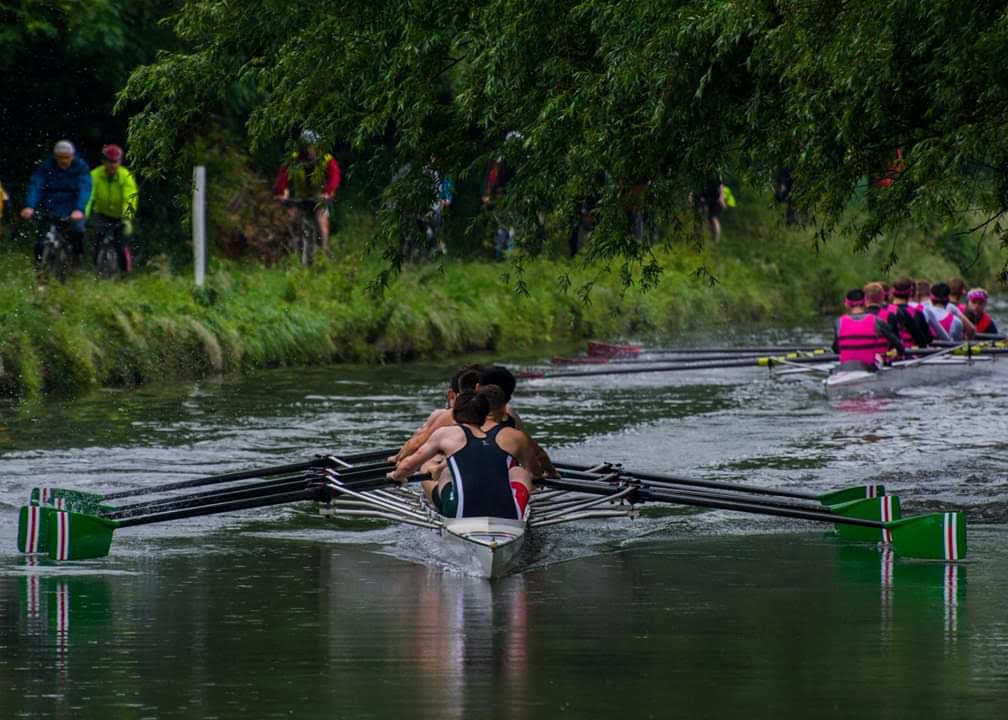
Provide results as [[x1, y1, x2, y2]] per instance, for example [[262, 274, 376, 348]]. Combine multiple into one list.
[[833, 277, 998, 371]]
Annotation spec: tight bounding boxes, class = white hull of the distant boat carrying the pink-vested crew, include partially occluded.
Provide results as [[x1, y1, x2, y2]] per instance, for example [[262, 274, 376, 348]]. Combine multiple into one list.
[[772, 355, 996, 398]]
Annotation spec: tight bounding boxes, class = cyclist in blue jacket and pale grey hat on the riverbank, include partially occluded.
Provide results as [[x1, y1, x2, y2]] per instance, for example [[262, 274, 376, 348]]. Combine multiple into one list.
[[21, 140, 91, 264]]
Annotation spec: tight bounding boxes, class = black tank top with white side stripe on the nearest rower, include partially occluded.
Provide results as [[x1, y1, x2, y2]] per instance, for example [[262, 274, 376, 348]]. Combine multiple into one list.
[[442, 425, 520, 519]]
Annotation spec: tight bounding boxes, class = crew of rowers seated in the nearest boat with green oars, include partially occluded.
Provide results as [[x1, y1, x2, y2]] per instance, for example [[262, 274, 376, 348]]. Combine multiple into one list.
[[388, 365, 556, 519]]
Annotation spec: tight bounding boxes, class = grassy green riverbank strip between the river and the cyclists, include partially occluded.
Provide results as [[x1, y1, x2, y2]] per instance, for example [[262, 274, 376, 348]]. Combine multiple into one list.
[[0, 198, 990, 399]]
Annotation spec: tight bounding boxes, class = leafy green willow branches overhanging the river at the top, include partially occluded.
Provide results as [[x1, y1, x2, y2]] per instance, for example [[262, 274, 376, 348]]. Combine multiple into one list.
[[123, 0, 1008, 276]]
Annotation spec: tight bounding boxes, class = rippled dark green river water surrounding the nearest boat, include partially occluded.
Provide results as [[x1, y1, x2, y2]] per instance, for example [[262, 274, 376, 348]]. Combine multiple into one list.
[[0, 338, 1008, 719]]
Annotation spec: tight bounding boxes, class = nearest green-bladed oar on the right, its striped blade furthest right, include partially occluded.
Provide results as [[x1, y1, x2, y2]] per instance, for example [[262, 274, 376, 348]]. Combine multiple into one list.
[[542, 478, 966, 561]]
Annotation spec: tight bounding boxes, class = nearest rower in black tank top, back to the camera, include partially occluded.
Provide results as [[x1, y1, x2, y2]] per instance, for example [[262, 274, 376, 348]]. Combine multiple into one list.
[[388, 391, 542, 519]]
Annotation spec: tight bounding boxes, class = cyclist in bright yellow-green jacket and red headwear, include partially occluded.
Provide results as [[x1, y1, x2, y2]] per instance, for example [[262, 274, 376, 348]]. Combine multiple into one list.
[[85, 145, 140, 272]]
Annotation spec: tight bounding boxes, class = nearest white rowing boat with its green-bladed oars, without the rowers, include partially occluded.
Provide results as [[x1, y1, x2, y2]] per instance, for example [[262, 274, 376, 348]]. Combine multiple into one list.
[[17, 450, 966, 580]]
